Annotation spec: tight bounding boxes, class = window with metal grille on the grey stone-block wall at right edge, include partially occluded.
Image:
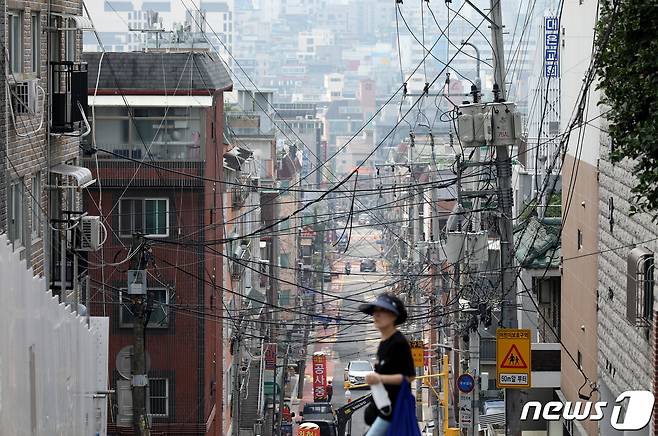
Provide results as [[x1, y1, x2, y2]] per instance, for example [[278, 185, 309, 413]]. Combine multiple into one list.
[[626, 247, 654, 327]]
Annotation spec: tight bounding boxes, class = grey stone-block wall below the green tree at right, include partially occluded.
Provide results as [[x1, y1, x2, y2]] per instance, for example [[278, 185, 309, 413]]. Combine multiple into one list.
[[598, 114, 658, 395]]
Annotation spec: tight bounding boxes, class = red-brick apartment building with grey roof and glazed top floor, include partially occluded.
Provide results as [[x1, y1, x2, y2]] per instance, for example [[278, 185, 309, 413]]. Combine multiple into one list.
[[84, 51, 232, 435]]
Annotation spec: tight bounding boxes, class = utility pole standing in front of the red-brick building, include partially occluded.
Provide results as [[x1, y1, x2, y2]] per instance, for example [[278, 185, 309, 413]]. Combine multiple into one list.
[[128, 233, 150, 436]]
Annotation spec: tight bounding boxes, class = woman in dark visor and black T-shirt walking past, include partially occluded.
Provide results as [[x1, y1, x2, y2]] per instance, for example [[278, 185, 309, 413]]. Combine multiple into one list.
[[359, 294, 416, 436]]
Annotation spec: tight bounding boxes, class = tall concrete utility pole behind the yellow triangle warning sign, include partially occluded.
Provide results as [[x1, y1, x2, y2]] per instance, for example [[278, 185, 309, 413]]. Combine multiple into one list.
[[490, 0, 521, 436]]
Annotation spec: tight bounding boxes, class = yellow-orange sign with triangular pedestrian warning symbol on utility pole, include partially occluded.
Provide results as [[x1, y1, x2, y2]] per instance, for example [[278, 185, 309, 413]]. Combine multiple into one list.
[[496, 329, 532, 389]]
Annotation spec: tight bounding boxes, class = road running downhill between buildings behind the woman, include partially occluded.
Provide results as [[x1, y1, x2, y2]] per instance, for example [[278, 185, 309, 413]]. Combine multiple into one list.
[[322, 227, 389, 436]]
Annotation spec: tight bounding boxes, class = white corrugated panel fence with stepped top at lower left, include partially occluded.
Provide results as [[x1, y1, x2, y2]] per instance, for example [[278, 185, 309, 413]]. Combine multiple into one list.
[[0, 235, 109, 436]]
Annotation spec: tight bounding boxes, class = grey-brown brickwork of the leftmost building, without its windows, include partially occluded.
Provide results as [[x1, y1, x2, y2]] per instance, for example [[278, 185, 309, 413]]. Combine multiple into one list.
[[0, 0, 82, 275]]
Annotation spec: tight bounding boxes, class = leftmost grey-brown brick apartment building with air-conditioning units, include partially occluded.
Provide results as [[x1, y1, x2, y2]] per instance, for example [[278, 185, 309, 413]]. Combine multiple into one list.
[[0, 0, 94, 296]]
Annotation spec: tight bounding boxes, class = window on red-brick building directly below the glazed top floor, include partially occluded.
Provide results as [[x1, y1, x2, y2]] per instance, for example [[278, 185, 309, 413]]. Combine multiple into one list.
[[119, 198, 169, 237]]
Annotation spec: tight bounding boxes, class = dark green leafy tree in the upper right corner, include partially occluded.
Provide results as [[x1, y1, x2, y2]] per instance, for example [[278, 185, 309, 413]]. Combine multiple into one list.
[[595, 0, 658, 220]]
